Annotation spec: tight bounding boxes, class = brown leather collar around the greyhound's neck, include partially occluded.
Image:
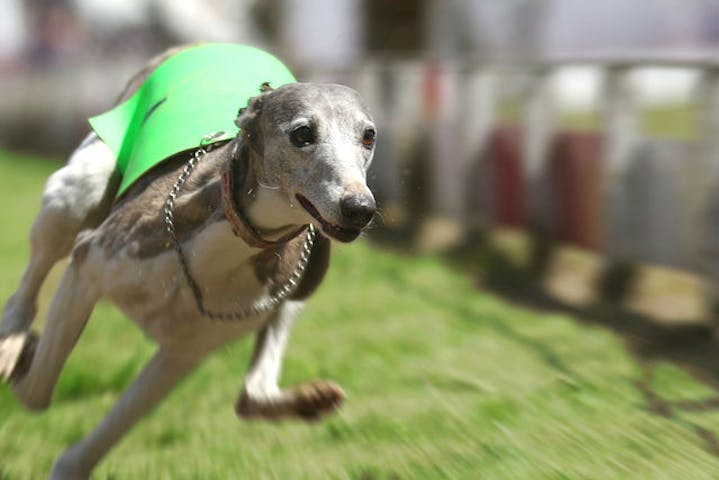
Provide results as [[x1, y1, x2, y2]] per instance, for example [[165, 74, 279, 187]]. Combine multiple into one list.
[[221, 140, 307, 249]]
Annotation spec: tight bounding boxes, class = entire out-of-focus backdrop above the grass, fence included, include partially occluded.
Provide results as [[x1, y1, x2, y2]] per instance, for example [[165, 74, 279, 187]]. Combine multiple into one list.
[[0, 0, 719, 293]]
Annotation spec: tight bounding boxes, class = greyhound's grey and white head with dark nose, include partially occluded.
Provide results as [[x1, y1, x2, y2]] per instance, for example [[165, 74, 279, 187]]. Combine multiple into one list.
[[237, 83, 377, 242]]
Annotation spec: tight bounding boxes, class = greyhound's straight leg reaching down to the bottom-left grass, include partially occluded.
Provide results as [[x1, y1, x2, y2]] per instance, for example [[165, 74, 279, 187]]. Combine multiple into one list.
[[50, 348, 202, 480]]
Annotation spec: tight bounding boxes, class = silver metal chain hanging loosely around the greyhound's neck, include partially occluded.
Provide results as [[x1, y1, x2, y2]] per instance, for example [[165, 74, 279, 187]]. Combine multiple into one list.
[[164, 134, 317, 321]]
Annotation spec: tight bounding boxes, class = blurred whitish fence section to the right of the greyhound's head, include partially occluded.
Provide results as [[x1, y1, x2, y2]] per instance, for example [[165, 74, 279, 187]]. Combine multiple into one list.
[[308, 55, 719, 279]]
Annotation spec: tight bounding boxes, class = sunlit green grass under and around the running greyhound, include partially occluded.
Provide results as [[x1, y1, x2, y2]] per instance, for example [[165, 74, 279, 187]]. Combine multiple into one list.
[[0, 155, 719, 480]]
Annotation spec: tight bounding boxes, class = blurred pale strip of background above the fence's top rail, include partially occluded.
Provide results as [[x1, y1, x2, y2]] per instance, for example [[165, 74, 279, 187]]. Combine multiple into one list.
[[0, 0, 719, 66]]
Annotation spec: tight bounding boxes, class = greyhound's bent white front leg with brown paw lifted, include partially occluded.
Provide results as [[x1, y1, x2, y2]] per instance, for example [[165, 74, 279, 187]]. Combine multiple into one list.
[[236, 301, 344, 420]]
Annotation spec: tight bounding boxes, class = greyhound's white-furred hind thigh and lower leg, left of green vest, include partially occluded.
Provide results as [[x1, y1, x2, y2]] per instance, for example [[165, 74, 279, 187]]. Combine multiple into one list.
[[0, 134, 120, 337]]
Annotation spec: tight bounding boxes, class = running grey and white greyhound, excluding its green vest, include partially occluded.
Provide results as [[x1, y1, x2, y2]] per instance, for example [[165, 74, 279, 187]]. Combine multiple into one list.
[[0, 46, 376, 480]]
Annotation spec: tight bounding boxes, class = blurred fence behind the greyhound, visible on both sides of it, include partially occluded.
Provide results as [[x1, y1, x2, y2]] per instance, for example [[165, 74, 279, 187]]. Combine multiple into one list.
[[0, 52, 719, 296]]
